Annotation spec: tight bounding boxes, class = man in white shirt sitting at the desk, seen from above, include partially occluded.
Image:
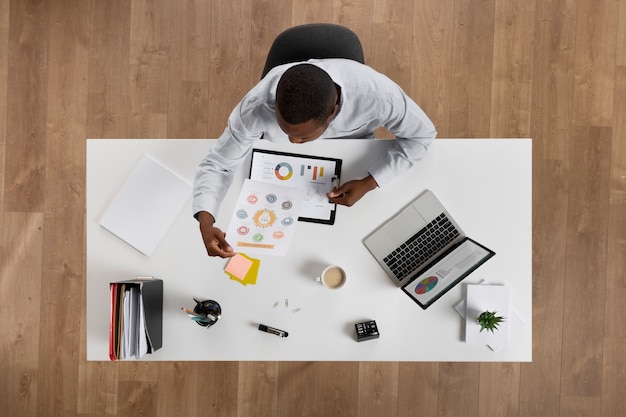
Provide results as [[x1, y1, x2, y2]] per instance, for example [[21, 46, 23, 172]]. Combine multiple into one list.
[[193, 59, 437, 258]]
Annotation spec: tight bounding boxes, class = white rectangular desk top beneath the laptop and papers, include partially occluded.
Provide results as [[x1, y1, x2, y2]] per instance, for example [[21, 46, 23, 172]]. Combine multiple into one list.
[[86, 139, 532, 362]]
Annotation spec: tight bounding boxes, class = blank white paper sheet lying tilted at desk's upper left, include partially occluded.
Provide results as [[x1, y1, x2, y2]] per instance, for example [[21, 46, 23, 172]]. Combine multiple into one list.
[[100, 155, 191, 256]]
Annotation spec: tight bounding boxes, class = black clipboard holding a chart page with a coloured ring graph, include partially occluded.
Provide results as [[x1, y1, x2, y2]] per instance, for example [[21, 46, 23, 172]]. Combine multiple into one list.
[[248, 148, 342, 225]]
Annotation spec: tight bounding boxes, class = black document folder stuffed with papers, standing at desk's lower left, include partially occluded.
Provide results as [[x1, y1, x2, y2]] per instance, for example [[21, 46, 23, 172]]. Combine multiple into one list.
[[109, 277, 163, 361]]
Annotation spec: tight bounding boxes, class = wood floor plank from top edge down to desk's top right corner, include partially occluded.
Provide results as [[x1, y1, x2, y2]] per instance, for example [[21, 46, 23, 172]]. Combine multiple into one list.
[[489, 0, 535, 138]]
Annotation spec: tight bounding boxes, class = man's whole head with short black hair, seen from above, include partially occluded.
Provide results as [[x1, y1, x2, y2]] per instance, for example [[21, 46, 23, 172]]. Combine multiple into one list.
[[276, 64, 338, 143]]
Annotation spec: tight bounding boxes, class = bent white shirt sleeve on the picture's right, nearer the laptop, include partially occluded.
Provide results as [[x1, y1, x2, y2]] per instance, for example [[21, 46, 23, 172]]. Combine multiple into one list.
[[369, 85, 437, 187]]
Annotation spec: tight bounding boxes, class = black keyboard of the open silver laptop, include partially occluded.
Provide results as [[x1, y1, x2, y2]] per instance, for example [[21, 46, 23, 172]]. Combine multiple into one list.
[[383, 213, 459, 281]]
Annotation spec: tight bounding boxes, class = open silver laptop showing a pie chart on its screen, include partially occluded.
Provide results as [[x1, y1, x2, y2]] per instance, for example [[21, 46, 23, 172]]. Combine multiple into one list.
[[363, 190, 495, 309]]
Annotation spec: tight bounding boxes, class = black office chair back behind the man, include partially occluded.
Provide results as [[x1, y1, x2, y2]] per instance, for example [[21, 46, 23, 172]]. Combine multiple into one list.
[[261, 23, 365, 78]]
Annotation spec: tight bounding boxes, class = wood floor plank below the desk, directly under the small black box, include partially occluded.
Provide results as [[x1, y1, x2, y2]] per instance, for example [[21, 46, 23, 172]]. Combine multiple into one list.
[[358, 362, 399, 417]]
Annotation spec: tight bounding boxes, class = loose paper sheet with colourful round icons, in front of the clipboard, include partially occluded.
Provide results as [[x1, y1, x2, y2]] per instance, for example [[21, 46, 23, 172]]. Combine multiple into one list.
[[226, 178, 306, 256]]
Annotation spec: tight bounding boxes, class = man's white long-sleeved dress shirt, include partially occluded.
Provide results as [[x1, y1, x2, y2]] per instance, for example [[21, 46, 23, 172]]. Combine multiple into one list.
[[193, 59, 437, 219]]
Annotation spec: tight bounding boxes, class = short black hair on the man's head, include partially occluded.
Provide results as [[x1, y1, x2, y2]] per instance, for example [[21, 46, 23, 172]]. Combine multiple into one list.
[[276, 64, 337, 125]]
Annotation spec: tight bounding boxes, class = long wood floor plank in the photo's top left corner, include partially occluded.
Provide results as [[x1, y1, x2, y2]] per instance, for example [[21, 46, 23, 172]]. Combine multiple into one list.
[[4, 0, 50, 212]]
